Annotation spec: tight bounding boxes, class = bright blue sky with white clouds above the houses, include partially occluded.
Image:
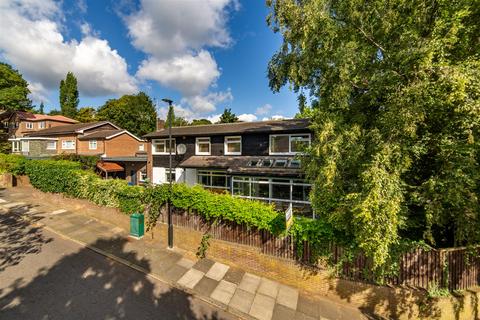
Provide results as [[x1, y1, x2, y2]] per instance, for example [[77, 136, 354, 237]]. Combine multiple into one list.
[[0, 0, 297, 121]]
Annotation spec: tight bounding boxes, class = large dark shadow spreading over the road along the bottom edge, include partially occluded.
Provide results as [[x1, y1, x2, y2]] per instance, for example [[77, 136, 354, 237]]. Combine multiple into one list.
[[0, 238, 229, 320]]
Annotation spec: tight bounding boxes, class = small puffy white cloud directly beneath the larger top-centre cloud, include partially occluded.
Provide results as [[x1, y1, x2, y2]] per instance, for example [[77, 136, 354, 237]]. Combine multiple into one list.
[[137, 50, 220, 97]]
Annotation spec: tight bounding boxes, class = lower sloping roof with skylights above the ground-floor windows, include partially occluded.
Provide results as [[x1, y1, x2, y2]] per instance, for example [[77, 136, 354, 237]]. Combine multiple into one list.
[[179, 156, 302, 176]]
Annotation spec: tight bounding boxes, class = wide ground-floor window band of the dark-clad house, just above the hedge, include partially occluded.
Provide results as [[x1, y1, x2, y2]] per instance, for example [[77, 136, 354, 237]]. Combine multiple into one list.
[[232, 176, 311, 214]]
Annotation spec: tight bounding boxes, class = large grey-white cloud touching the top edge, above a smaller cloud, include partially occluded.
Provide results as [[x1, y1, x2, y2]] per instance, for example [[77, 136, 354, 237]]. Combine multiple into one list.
[[124, 0, 232, 59]]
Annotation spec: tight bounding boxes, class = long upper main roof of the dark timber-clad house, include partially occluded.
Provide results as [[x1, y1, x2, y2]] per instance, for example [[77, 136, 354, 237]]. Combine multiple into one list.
[[144, 119, 310, 138]]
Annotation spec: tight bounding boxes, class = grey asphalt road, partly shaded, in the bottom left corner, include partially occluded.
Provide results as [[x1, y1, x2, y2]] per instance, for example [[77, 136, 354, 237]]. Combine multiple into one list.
[[0, 208, 236, 320]]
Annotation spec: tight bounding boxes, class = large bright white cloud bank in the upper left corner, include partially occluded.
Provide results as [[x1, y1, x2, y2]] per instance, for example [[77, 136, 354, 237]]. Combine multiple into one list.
[[0, 0, 137, 101]]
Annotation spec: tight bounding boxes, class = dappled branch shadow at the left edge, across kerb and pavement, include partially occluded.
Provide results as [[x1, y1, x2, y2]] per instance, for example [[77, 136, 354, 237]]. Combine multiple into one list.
[[0, 205, 52, 272]]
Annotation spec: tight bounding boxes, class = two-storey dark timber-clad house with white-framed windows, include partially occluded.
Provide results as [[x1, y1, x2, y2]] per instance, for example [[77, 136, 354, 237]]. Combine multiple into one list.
[[145, 119, 312, 215]]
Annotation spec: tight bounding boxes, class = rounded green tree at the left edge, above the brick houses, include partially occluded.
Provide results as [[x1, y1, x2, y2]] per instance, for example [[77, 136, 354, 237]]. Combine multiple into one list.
[[0, 62, 32, 111]]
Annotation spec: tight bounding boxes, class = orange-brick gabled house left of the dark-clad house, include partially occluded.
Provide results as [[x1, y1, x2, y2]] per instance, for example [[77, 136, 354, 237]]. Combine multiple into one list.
[[10, 121, 147, 184]]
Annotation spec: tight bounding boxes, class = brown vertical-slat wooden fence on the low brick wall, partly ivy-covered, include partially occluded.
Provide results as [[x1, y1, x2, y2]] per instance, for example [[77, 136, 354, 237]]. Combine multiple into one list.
[[159, 209, 480, 290]]
